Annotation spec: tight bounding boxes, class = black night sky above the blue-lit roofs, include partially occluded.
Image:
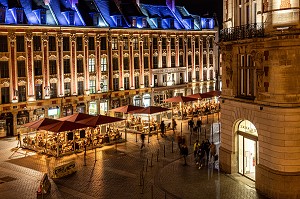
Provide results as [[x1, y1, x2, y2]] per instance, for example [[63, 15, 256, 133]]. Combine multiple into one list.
[[140, 0, 223, 22]]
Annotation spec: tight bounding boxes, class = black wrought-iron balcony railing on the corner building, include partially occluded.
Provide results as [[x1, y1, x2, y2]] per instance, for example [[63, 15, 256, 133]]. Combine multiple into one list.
[[220, 23, 264, 41]]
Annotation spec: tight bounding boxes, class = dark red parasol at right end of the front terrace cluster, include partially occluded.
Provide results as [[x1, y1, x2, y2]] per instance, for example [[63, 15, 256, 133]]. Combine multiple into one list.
[[76, 115, 124, 128]]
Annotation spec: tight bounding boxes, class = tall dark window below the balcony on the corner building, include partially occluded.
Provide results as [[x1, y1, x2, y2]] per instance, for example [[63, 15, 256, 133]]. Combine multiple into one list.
[[238, 55, 255, 97]]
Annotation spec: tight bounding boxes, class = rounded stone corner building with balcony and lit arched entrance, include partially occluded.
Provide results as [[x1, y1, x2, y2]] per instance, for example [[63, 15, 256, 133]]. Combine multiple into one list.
[[220, 0, 300, 198]]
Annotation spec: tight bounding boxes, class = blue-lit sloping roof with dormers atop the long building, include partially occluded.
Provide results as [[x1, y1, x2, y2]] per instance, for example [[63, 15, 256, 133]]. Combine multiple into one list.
[[0, 0, 215, 30]]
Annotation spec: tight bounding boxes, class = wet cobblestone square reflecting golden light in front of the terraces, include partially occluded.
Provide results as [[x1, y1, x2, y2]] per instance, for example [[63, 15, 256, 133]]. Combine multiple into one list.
[[0, 113, 264, 199]]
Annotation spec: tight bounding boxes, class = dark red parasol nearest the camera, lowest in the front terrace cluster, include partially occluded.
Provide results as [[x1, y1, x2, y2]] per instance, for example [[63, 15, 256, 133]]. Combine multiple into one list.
[[40, 121, 88, 133]]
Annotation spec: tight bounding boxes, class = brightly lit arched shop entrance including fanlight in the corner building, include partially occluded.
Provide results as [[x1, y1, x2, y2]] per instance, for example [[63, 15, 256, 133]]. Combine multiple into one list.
[[235, 120, 258, 181]]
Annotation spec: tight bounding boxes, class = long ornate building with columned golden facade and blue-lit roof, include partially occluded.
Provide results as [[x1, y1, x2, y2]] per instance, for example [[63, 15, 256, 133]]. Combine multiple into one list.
[[0, 0, 218, 137]]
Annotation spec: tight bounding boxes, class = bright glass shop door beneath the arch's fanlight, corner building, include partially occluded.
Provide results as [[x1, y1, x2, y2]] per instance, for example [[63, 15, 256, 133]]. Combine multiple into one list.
[[238, 135, 257, 180]]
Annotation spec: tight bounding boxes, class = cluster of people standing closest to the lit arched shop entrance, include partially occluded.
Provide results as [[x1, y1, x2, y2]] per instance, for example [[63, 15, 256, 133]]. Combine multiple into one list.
[[194, 139, 217, 169]]
